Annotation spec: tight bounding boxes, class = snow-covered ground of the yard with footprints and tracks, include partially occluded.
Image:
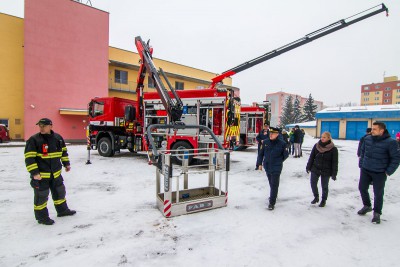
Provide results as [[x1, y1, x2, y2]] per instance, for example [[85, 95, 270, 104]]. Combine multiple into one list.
[[0, 137, 400, 267]]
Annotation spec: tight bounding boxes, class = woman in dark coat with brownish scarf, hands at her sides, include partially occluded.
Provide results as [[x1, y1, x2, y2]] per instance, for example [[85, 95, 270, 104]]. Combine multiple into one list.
[[306, 132, 339, 207]]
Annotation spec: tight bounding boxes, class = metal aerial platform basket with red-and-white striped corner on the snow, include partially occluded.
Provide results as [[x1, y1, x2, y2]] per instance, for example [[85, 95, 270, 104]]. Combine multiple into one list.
[[147, 124, 230, 218]]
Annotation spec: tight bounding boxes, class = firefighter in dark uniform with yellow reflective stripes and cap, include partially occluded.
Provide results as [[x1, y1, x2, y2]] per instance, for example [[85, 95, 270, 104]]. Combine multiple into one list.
[[25, 118, 76, 225]]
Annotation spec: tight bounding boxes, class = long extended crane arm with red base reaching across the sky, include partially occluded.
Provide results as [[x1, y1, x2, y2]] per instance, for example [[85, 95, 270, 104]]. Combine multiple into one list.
[[210, 3, 388, 89]]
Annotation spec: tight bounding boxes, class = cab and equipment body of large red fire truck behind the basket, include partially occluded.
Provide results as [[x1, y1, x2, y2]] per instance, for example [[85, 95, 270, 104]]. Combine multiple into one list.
[[89, 89, 240, 161]]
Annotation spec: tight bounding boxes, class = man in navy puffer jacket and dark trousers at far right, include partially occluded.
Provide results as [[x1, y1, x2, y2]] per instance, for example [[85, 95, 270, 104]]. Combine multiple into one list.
[[358, 121, 400, 223]]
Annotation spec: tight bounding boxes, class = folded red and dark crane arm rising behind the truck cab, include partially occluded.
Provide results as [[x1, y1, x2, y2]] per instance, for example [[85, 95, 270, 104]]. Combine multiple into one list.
[[135, 36, 183, 124]]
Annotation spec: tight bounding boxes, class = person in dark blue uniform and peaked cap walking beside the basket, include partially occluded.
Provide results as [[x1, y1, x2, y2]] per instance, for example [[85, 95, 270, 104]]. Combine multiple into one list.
[[263, 127, 289, 210]]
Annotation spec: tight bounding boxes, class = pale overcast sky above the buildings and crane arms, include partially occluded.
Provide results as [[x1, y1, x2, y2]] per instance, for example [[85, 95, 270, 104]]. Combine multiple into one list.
[[0, 0, 400, 106]]
